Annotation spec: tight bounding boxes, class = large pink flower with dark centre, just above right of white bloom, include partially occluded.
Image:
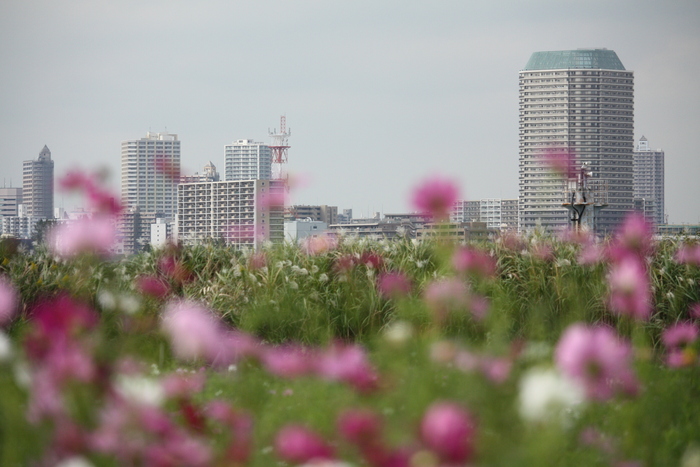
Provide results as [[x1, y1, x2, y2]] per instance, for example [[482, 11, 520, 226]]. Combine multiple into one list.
[[555, 323, 638, 400]]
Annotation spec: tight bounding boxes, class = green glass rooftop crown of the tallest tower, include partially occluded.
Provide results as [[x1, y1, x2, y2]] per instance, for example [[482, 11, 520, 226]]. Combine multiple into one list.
[[525, 49, 625, 70]]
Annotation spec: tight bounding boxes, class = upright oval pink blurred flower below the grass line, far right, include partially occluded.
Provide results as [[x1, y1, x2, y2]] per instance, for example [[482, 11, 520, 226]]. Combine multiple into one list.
[[608, 256, 652, 321]]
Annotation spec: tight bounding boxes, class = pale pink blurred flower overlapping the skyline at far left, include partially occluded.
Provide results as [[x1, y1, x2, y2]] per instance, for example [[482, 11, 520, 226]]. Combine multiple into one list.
[[47, 216, 117, 258]]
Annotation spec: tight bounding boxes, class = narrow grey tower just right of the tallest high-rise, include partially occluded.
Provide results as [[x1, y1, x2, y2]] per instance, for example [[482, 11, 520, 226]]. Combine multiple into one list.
[[634, 136, 666, 225]]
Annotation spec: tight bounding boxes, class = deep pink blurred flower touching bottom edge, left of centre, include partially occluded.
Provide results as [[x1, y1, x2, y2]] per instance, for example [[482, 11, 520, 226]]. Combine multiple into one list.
[[275, 425, 334, 465]]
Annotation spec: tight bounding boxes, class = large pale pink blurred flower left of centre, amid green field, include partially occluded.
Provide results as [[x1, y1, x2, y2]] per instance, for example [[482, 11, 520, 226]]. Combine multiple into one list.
[[161, 300, 225, 362]]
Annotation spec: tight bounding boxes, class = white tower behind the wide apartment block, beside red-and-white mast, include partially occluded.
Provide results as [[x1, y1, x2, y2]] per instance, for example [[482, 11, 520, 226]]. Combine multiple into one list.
[[225, 139, 272, 181]]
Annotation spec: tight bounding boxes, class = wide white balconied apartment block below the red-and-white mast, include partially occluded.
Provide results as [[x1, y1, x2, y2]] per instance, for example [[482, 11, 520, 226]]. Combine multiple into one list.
[[175, 180, 285, 249]]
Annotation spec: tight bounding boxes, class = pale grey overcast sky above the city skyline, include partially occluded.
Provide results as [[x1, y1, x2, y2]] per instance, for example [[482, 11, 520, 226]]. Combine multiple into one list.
[[0, 0, 700, 223]]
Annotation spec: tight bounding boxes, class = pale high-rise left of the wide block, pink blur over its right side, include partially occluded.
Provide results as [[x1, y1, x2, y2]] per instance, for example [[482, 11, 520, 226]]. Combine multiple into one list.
[[122, 132, 180, 218]]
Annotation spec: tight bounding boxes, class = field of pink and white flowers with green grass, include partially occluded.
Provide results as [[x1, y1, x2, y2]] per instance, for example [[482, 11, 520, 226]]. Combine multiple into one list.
[[0, 174, 700, 467]]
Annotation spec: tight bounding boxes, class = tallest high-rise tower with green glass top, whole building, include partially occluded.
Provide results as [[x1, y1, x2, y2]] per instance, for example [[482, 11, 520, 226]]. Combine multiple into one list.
[[519, 49, 634, 233]]
